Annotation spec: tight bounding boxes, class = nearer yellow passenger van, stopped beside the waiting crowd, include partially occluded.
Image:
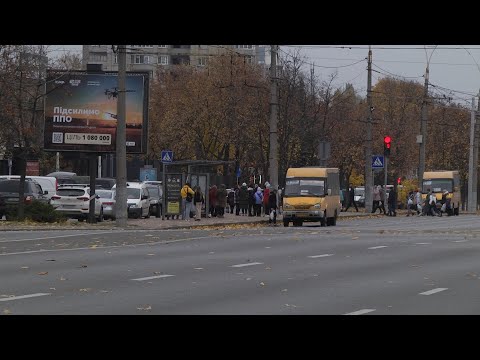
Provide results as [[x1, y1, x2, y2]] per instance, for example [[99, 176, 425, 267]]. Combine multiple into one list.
[[283, 167, 341, 226]]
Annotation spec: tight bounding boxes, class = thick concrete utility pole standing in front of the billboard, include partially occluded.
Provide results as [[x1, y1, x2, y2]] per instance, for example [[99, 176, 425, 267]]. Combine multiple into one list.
[[115, 45, 128, 228]]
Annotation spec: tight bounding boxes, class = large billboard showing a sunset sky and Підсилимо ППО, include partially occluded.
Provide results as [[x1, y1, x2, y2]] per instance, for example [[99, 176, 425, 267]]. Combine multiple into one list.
[[44, 72, 148, 154]]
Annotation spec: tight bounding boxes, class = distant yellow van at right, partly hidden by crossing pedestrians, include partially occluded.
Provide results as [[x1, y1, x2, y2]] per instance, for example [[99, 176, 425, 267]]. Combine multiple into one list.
[[422, 170, 462, 215]]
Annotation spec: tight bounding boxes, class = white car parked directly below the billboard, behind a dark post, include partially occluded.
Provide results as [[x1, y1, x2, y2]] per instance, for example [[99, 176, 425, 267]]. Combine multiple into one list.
[[50, 185, 103, 222]]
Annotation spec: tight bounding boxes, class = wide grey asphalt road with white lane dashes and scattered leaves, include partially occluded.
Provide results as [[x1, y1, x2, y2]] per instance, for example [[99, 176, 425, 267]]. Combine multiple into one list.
[[0, 215, 480, 315]]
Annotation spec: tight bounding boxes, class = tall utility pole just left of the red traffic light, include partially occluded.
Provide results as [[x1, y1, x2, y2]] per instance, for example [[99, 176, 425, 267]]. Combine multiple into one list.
[[365, 45, 373, 213]]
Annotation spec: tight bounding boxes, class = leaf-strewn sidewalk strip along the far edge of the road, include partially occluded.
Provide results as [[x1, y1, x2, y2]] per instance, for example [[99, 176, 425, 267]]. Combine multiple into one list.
[[0, 210, 379, 231]]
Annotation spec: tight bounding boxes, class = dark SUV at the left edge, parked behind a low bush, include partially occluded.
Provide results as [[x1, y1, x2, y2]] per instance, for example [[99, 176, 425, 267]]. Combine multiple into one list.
[[0, 179, 48, 218]]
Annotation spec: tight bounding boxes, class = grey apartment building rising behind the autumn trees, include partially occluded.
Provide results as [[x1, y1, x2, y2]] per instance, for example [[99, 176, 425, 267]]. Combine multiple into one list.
[[82, 45, 265, 73]]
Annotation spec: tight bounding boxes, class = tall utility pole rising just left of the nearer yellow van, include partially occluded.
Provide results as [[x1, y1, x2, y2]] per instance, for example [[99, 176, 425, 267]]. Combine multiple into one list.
[[269, 45, 278, 190]]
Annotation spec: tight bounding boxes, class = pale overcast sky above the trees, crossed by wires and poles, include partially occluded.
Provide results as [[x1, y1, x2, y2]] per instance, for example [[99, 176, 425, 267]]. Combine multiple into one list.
[[52, 45, 480, 104]]
